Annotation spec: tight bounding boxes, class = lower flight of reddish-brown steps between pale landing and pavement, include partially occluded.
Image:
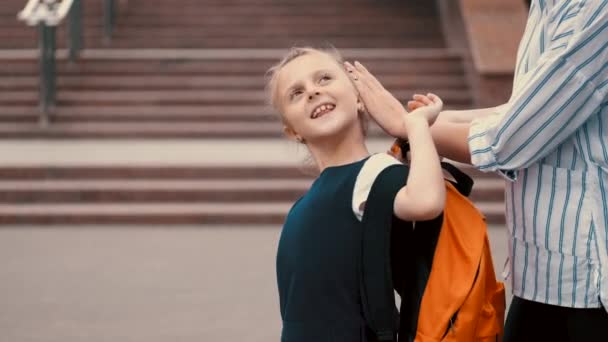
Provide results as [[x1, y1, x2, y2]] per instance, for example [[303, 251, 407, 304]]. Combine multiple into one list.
[[0, 160, 504, 225]]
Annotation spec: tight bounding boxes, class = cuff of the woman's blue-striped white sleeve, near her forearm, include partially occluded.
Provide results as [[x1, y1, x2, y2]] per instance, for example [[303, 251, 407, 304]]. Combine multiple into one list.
[[468, 115, 517, 181]]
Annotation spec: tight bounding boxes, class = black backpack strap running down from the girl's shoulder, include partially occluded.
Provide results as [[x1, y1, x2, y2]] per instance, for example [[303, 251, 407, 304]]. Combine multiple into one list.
[[361, 165, 407, 341]]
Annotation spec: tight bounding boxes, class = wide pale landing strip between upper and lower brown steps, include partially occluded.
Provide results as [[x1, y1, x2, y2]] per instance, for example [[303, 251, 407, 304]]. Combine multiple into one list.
[[0, 138, 400, 166]]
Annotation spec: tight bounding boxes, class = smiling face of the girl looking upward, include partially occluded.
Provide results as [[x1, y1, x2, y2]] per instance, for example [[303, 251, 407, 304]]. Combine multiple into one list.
[[276, 52, 361, 143]]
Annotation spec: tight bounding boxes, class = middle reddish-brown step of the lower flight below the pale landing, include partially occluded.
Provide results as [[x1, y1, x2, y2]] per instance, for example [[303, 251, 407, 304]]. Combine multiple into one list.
[[0, 177, 504, 204]]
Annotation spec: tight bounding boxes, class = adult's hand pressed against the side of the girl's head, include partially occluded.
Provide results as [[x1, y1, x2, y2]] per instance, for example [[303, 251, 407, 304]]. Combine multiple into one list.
[[344, 62, 408, 138]]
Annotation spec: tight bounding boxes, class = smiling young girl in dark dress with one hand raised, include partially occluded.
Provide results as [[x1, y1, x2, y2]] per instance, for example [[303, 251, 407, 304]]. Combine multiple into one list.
[[268, 48, 445, 342]]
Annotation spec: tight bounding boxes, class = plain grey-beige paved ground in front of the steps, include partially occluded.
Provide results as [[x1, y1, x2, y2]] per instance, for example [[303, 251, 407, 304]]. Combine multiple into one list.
[[0, 226, 506, 342]]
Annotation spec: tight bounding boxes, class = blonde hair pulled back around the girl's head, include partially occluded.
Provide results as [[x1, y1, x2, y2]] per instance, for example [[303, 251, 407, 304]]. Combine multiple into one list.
[[266, 47, 369, 136]]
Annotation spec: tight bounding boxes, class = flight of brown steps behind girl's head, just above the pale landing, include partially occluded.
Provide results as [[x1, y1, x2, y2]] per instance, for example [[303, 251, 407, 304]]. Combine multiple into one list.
[[0, 49, 471, 139]]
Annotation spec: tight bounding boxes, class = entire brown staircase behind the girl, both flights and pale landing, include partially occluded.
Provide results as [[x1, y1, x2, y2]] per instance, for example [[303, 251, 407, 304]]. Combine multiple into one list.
[[0, 0, 503, 224]]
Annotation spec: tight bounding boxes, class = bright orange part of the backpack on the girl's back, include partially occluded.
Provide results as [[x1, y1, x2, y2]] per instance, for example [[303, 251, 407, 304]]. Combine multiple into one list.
[[415, 183, 505, 342]]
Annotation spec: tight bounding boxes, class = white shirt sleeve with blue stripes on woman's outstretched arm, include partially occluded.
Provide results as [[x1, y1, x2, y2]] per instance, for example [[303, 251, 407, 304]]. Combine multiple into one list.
[[468, 9, 608, 175]]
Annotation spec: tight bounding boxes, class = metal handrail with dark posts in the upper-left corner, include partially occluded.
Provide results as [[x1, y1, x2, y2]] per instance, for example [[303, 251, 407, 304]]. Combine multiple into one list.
[[17, 0, 82, 126]]
